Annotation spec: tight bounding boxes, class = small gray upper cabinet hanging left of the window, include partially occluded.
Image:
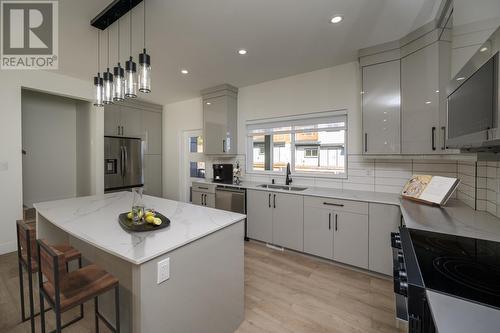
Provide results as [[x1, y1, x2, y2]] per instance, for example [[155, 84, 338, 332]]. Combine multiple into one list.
[[202, 84, 238, 155]]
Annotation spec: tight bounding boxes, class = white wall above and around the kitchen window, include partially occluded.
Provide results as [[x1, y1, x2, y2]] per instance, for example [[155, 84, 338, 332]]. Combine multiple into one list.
[[238, 62, 361, 154]]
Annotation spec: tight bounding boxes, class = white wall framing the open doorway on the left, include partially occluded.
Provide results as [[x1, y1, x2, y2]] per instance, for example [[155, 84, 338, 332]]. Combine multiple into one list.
[[0, 70, 104, 254]]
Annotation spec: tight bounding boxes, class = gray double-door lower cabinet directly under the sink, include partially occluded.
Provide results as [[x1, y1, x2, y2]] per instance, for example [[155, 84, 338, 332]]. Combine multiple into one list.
[[247, 190, 304, 251]]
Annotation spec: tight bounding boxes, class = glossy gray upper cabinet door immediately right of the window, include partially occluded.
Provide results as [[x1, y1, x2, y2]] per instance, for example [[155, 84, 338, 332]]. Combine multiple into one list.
[[362, 60, 401, 154]]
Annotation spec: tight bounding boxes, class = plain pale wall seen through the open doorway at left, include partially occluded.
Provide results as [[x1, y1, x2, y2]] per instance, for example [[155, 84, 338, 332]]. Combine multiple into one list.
[[21, 90, 77, 207]]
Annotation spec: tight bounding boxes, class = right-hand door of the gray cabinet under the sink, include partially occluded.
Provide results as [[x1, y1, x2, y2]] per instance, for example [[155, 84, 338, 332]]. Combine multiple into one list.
[[273, 193, 304, 251]]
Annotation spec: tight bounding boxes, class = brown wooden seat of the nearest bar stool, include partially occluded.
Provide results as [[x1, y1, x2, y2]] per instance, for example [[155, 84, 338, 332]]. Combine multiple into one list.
[[43, 265, 118, 312]]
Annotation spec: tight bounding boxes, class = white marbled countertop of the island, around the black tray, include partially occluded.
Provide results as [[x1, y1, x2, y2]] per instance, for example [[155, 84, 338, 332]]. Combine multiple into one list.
[[34, 192, 245, 264]]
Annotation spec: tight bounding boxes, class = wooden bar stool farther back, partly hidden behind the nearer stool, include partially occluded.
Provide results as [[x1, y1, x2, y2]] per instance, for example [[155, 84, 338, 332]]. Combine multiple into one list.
[[16, 220, 83, 332]]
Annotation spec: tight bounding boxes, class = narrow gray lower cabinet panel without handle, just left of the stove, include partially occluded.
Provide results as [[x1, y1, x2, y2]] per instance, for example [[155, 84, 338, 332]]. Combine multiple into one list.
[[368, 203, 401, 275]]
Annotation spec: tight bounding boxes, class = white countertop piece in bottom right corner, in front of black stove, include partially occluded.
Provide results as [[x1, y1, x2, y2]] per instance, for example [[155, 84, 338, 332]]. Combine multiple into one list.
[[427, 290, 500, 333]]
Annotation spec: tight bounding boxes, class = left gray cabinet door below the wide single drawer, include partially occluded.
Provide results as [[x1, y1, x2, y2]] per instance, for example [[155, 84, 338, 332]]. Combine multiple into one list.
[[304, 206, 334, 259]]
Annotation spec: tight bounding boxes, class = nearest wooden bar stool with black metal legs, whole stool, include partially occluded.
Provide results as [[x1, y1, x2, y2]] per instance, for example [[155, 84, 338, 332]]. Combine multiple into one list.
[[37, 240, 120, 333]]
